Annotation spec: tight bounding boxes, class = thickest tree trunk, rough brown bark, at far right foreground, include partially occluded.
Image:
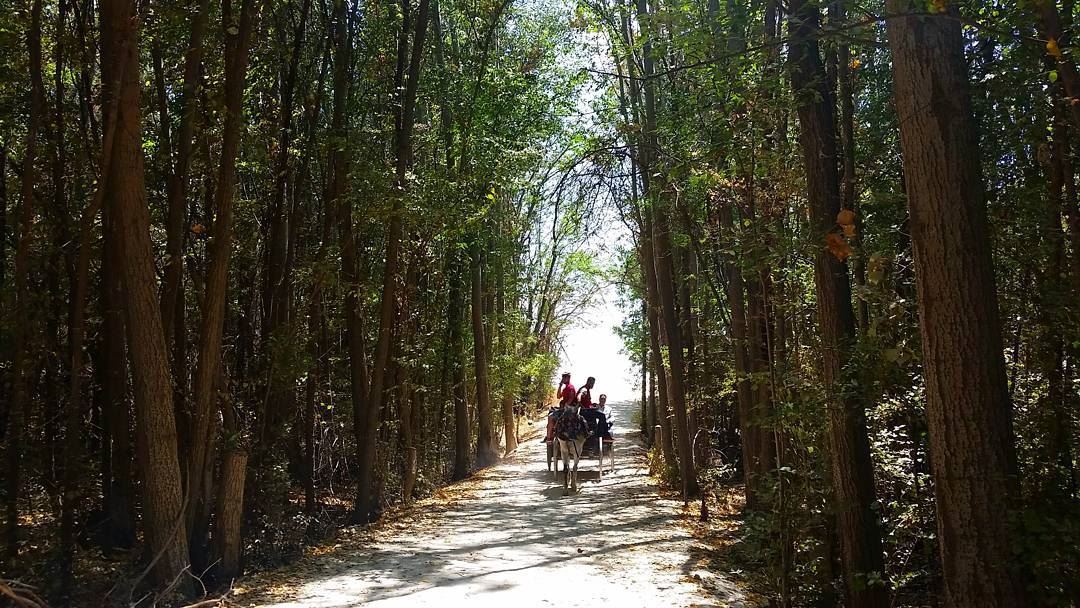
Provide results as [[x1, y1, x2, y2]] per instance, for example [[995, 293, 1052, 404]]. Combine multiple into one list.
[[887, 0, 1027, 608]]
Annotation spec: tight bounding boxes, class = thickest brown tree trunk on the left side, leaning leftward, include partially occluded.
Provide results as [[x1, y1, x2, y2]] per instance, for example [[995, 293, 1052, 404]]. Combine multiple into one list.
[[100, 0, 188, 586]]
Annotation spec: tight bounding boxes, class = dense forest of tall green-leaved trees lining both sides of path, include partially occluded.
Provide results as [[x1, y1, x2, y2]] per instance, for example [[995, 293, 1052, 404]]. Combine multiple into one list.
[[0, 0, 1080, 608]]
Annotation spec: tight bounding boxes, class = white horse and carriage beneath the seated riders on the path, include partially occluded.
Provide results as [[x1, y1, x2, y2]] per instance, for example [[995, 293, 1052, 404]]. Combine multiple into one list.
[[546, 406, 615, 490]]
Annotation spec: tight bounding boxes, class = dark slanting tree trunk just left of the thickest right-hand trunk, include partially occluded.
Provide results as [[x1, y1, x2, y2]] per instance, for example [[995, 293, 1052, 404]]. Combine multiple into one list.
[[788, 0, 889, 608]]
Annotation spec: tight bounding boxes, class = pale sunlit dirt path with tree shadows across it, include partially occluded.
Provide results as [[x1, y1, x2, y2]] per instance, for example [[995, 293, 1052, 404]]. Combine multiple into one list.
[[238, 404, 748, 608]]
